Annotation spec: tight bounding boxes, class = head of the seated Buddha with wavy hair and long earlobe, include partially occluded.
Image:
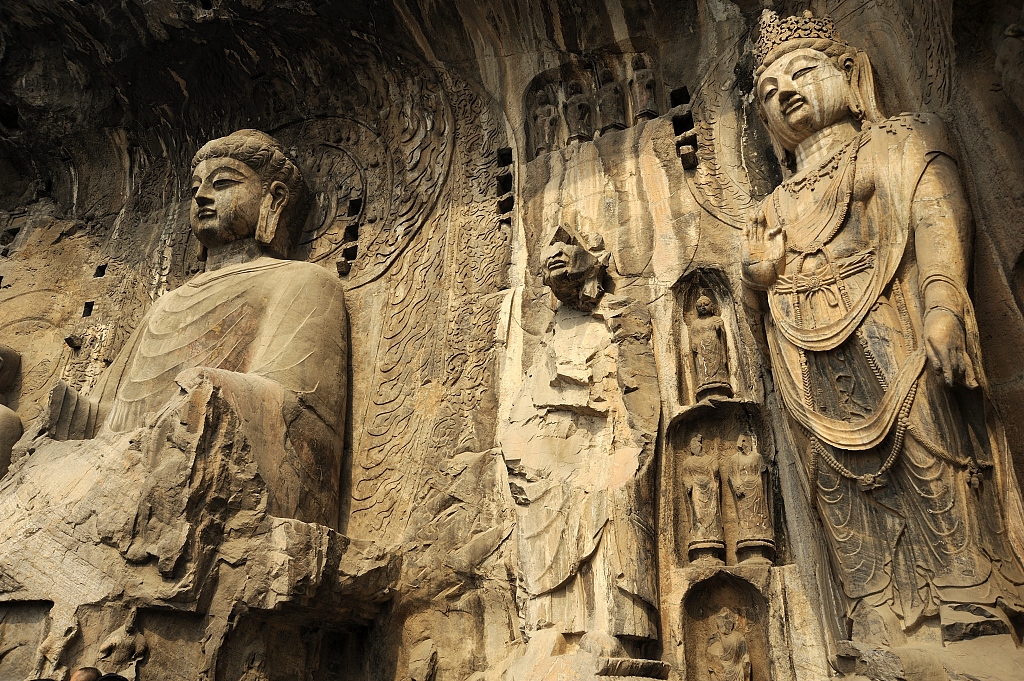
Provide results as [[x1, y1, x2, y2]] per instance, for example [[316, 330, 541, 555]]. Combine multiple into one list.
[[190, 130, 308, 257]]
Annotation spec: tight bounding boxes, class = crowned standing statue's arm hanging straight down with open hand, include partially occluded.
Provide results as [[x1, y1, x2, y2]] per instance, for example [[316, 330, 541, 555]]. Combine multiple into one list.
[[910, 155, 978, 387]]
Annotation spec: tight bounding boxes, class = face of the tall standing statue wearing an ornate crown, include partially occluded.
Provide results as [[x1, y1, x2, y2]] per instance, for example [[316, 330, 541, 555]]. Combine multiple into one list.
[[757, 48, 853, 152]]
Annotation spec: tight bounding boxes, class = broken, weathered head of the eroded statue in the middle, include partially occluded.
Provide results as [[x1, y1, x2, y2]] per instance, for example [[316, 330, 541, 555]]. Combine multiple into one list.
[[541, 226, 610, 310]]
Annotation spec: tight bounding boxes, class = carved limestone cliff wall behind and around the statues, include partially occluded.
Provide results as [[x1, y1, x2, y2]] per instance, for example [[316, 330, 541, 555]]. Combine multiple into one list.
[[0, 0, 1024, 681]]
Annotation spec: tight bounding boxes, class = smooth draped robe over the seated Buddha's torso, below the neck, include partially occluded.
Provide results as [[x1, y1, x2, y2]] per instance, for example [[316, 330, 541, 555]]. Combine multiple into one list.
[[89, 258, 348, 526]]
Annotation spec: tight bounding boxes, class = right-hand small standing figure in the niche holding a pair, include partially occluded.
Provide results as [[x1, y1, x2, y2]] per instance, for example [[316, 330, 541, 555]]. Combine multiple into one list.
[[728, 434, 775, 563]]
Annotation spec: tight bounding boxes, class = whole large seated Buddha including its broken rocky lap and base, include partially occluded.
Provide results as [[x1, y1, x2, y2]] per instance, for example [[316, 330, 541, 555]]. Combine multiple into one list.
[[0, 130, 373, 678]]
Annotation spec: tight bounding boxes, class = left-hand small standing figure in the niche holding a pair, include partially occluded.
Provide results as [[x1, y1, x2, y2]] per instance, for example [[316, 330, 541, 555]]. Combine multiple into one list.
[[680, 433, 725, 564]]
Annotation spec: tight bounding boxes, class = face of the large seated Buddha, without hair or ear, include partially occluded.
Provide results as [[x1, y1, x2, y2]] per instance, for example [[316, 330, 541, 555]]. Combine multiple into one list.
[[190, 158, 263, 248]]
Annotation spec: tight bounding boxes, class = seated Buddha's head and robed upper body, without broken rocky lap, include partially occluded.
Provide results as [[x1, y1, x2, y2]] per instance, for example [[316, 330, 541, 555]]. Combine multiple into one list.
[[35, 130, 348, 527]]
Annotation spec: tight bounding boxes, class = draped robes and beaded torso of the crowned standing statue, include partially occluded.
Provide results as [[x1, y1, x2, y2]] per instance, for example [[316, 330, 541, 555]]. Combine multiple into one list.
[[765, 115, 1024, 629]]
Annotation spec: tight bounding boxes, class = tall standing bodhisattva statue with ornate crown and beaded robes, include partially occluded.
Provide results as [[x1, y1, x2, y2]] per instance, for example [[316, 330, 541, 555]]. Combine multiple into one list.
[[741, 11, 1024, 644]]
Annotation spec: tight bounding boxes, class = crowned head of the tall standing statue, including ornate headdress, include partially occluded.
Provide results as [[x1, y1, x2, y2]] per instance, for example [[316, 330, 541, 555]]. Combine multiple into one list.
[[754, 9, 884, 166]]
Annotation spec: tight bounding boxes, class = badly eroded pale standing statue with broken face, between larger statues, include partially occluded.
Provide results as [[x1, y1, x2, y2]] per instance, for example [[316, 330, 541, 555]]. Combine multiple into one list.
[[501, 224, 659, 659]]
